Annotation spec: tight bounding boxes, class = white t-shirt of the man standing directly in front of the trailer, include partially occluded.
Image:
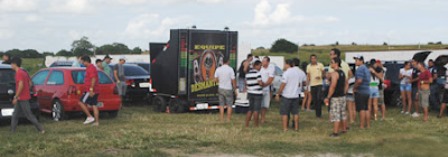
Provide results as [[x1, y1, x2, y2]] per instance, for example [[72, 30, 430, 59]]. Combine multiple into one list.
[[215, 64, 235, 90]]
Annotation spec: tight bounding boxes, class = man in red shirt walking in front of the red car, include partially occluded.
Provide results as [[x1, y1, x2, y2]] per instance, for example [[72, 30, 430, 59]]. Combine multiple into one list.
[[78, 56, 100, 126]]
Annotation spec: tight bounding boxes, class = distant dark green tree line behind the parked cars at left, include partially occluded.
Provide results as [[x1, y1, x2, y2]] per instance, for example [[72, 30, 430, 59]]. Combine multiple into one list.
[[0, 36, 143, 58]]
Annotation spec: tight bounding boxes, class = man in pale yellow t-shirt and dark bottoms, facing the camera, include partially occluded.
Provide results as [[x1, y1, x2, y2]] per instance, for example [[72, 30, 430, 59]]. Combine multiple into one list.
[[306, 54, 325, 118]]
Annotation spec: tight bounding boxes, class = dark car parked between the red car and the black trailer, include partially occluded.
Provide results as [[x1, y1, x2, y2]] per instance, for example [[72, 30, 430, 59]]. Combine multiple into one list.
[[110, 64, 151, 101]]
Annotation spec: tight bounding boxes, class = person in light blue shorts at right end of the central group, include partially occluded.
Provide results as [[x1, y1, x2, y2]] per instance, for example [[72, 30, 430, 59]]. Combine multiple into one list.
[[369, 59, 383, 121]]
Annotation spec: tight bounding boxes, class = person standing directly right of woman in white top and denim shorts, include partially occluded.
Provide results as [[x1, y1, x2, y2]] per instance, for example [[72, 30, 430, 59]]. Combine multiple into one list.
[[411, 60, 420, 118]]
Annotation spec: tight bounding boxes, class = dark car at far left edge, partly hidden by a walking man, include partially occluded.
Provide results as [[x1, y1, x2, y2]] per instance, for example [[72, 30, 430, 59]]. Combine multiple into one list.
[[0, 64, 40, 119]]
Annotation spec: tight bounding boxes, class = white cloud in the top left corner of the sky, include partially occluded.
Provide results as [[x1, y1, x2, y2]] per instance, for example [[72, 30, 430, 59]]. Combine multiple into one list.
[[0, 0, 39, 12]]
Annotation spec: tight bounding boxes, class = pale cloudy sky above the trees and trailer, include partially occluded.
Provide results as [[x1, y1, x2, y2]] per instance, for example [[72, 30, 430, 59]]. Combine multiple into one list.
[[0, 0, 448, 52]]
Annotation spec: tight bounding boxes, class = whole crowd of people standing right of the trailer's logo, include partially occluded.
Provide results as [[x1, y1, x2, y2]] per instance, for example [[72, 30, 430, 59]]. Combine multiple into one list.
[[215, 49, 448, 137]]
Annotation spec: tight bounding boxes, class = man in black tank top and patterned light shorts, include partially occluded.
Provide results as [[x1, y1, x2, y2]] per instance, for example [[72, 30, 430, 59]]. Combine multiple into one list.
[[325, 58, 348, 137]]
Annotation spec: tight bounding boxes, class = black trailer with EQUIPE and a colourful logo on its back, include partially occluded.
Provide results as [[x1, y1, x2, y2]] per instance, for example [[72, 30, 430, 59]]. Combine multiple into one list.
[[149, 29, 238, 113]]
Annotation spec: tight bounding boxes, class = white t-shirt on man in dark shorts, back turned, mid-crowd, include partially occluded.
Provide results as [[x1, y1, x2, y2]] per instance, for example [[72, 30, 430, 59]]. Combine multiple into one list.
[[281, 68, 300, 99]]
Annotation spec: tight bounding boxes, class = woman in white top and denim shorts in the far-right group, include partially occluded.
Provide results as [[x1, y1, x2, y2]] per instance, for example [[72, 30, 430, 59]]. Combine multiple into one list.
[[399, 62, 412, 114]]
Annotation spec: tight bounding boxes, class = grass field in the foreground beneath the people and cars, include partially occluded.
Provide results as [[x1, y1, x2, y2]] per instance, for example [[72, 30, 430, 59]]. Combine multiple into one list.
[[0, 104, 448, 157]]
